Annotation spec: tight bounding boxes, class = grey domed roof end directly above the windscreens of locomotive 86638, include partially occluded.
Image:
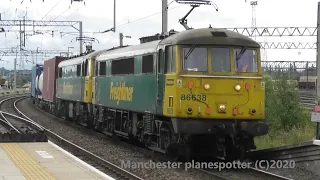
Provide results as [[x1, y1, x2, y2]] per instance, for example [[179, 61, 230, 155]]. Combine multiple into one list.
[[160, 28, 260, 48]]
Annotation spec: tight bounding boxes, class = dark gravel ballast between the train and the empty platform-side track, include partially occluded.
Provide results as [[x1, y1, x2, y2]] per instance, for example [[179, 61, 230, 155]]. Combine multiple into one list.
[[18, 98, 213, 180]]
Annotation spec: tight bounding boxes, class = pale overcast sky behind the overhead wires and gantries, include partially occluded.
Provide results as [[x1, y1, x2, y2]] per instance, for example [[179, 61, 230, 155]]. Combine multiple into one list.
[[0, 0, 318, 69]]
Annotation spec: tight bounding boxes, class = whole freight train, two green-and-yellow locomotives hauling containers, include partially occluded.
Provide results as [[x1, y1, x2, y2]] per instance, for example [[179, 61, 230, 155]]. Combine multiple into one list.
[[31, 28, 268, 160]]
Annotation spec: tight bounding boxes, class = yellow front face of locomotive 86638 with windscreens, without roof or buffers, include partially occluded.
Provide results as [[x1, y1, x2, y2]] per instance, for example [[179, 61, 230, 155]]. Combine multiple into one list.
[[166, 46, 265, 120]]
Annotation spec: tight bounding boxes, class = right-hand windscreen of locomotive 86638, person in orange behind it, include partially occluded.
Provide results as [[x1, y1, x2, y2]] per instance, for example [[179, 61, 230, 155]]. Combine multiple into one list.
[[234, 48, 258, 73]]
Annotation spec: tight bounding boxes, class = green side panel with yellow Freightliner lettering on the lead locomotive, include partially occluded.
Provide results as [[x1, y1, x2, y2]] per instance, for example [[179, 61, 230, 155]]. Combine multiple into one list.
[[96, 56, 157, 113]]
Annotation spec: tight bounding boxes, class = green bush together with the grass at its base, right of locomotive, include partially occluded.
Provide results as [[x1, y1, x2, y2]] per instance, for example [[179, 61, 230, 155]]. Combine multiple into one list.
[[255, 77, 316, 149]]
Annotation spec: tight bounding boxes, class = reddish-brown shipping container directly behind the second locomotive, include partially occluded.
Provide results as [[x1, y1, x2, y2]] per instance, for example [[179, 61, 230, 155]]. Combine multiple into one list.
[[42, 56, 65, 102]]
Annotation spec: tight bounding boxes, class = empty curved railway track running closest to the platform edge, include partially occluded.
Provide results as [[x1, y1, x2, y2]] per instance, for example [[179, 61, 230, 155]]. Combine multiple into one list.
[[11, 97, 142, 180]]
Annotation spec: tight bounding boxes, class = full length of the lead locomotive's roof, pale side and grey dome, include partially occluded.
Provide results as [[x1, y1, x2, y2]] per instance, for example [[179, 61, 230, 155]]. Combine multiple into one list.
[[97, 28, 260, 61]]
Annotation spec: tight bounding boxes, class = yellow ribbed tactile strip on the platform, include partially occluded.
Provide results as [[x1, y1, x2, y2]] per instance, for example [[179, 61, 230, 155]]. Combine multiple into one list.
[[1, 143, 57, 180]]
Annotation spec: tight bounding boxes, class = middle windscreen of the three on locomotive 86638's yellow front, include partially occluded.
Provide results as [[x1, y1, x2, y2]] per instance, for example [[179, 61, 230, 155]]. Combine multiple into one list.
[[211, 48, 231, 72]]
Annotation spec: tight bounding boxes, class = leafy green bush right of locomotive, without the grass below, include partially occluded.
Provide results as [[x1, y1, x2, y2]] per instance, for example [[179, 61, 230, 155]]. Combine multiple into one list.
[[265, 77, 311, 131]]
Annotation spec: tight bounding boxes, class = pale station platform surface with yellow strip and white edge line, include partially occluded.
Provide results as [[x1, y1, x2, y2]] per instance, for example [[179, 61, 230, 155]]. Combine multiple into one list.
[[0, 142, 113, 180]]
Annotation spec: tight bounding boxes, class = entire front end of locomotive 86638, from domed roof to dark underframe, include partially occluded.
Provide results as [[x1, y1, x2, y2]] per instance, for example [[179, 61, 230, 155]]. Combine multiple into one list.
[[163, 28, 268, 159]]
